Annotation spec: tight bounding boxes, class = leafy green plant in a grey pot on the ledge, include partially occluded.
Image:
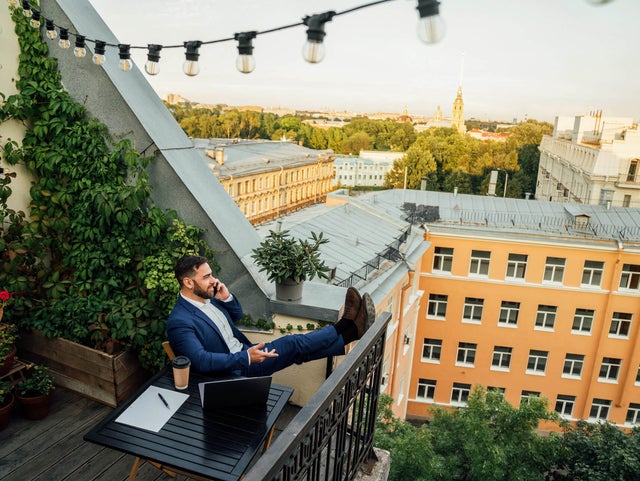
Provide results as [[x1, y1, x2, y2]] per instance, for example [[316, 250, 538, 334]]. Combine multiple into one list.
[[251, 230, 329, 301]]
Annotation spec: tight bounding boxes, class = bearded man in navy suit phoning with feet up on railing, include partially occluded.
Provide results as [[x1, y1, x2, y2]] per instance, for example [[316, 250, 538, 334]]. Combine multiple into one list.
[[167, 256, 375, 376]]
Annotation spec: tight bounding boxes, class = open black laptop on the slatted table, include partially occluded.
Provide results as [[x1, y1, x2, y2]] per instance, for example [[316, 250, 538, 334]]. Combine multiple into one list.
[[198, 376, 271, 410]]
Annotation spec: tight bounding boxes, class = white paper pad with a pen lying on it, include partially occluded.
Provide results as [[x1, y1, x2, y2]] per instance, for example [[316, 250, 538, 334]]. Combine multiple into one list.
[[116, 386, 189, 433]]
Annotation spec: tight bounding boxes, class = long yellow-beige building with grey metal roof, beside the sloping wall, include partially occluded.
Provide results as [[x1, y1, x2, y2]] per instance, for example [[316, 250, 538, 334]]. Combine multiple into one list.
[[194, 139, 334, 225]]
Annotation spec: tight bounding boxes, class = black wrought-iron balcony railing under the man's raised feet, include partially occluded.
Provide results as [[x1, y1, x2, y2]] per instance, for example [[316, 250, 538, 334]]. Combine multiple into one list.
[[243, 312, 391, 481]]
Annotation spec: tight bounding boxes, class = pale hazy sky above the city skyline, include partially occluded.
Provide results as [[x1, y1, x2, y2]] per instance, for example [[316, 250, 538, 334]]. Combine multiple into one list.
[[87, 0, 640, 122]]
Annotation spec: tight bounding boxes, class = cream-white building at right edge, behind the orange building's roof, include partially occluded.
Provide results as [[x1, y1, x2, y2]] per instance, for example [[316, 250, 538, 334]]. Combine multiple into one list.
[[535, 111, 640, 207]]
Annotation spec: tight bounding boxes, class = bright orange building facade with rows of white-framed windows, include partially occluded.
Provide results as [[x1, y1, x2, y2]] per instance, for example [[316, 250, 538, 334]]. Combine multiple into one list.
[[406, 229, 640, 427]]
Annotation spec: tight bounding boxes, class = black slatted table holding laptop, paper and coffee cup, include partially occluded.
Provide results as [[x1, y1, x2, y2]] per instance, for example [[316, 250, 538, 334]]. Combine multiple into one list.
[[84, 366, 293, 481]]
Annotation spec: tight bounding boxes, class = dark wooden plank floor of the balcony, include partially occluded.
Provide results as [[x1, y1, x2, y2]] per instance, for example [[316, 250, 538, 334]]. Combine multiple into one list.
[[0, 388, 297, 481]]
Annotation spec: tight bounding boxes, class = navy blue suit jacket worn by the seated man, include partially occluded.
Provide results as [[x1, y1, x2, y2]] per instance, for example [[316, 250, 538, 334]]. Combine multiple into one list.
[[167, 296, 252, 374]]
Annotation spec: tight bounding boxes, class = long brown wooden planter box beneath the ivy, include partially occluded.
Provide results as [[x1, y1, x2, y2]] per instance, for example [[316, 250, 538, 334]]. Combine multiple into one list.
[[18, 331, 151, 407]]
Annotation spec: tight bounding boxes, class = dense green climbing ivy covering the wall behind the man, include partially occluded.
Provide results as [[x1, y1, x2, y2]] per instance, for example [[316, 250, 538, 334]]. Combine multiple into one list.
[[0, 4, 217, 369]]
